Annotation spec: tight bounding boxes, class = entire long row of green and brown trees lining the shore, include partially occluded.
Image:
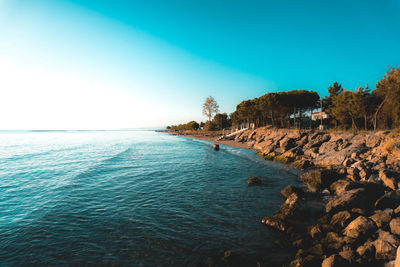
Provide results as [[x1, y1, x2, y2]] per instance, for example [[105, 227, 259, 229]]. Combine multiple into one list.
[[169, 68, 400, 130]]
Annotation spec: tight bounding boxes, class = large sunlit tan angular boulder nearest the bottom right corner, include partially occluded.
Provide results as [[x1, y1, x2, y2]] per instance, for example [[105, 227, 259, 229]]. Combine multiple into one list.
[[374, 230, 400, 261]]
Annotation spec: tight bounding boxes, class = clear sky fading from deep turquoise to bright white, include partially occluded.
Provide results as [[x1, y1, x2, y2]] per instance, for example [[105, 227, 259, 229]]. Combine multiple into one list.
[[0, 0, 400, 130]]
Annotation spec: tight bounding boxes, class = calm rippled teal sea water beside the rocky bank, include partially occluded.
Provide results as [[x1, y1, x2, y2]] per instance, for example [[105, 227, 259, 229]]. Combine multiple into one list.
[[0, 131, 299, 266]]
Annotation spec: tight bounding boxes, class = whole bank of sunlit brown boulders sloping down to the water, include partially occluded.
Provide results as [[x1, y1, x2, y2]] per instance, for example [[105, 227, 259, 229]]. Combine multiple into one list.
[[225, 128, 400, 267]]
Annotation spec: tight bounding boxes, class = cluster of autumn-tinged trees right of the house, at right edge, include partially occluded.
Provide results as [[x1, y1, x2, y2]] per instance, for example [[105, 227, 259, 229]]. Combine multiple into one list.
[[323, 68, 400, 130]]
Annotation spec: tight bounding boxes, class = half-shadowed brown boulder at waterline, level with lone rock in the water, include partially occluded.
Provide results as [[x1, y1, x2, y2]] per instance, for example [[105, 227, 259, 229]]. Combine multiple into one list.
[[301, 169, 338, 191]]
